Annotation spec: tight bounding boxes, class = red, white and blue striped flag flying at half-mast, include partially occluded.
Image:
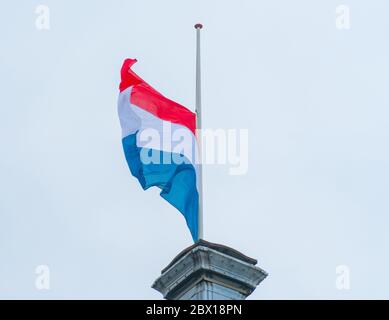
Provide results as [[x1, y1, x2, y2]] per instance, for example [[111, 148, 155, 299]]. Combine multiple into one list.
[[118, 59, 199, 241]]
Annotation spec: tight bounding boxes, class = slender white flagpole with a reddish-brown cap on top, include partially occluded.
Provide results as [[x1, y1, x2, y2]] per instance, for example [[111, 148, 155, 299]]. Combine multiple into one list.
[[194, 23, 204, 239]]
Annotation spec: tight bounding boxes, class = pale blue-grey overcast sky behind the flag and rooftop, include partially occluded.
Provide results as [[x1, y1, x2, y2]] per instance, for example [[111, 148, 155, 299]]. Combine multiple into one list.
[[0, 0, 389, 299]]
